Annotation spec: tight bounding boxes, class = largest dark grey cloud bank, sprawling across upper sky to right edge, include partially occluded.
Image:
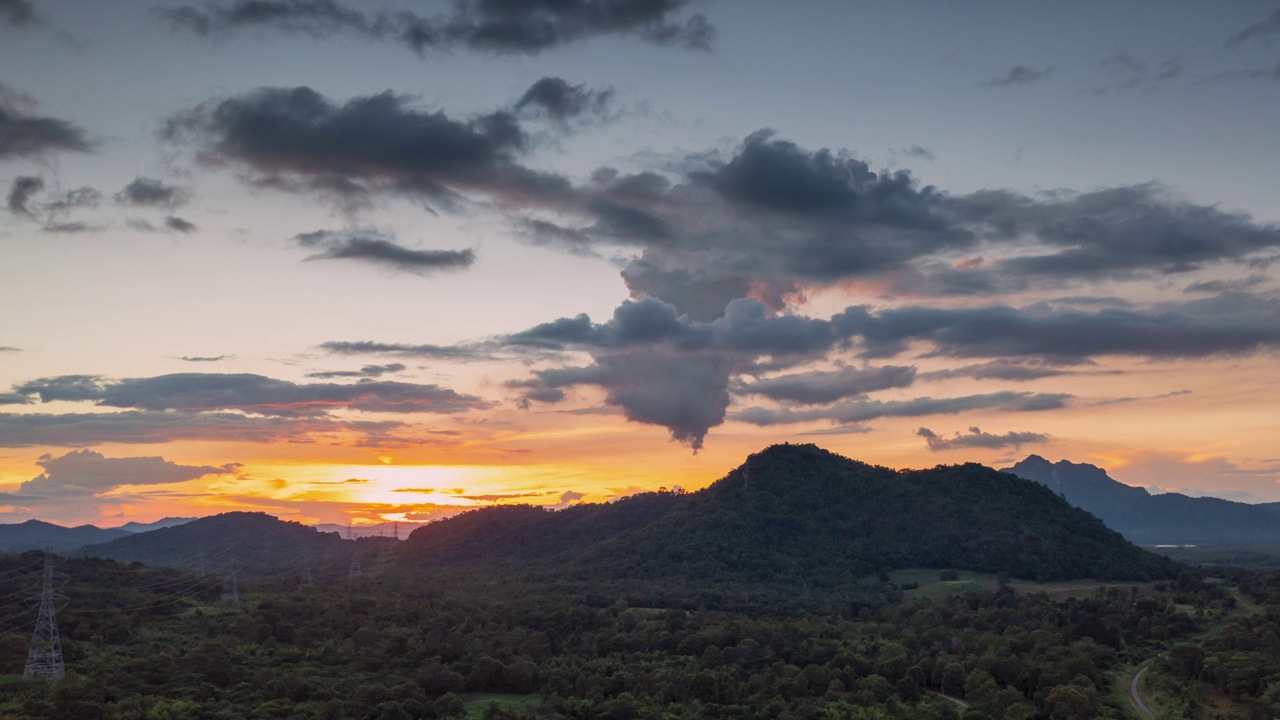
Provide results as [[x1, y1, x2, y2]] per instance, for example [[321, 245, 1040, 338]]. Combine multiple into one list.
[[173, 87, 1280, 320]]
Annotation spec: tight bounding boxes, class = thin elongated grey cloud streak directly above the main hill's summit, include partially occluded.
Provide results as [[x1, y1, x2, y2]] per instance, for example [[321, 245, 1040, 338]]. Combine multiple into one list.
[[731, 392, 1071, 427]]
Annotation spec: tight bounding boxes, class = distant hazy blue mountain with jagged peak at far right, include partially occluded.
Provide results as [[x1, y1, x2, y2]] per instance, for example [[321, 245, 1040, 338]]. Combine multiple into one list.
[[1005, 455, 1280, 544]]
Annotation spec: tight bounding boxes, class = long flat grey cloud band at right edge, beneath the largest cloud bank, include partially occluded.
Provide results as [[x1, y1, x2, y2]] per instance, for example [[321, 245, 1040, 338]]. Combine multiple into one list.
[[832, 293, 1280, 361]]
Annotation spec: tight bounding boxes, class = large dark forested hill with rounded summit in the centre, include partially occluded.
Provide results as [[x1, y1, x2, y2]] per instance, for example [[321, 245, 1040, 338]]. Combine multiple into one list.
[[404, 445, 1176, 584]]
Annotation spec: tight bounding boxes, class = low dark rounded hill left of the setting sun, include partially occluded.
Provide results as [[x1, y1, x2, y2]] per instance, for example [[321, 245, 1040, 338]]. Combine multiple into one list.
[[77, 512, 353, 577]]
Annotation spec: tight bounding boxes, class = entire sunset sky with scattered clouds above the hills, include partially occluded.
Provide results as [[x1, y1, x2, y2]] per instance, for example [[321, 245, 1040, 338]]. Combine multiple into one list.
[[0, 0, 1280, 525]]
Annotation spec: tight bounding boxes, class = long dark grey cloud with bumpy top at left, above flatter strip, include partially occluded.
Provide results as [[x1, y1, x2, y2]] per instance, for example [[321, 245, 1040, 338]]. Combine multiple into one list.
[[13, 373, 489, 416]]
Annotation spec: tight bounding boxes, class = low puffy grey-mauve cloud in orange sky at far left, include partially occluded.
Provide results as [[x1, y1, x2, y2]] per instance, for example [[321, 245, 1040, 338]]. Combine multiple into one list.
[[18, 450, 239, 498]]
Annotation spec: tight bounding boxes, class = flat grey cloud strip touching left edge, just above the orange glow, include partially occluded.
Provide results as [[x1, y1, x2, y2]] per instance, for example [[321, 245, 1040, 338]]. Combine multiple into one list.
[[0, 410, 402, 447]]
